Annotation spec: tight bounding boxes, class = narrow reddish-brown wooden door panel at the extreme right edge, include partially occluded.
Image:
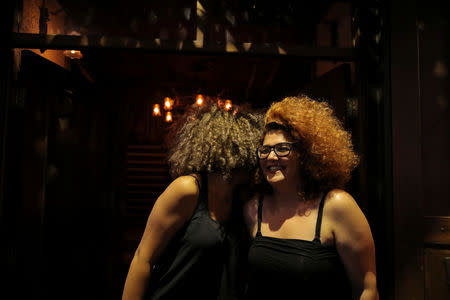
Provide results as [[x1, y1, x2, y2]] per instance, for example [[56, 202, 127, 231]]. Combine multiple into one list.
[[417, 1, 450, 300]]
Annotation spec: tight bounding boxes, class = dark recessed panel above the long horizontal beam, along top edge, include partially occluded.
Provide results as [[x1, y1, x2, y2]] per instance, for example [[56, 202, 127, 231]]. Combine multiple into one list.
[[58, 0, 338, 44]]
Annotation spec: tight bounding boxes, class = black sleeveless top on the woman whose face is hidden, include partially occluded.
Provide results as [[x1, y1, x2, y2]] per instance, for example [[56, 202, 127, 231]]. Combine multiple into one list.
[[146, 175, 244, 300]]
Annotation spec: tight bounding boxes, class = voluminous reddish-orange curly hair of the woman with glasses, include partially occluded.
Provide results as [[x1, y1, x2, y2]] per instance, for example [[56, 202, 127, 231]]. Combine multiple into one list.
[[264, 95, 359, 197]]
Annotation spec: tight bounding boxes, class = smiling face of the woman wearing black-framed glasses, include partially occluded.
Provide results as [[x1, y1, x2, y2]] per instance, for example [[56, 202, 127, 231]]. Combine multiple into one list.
[[259, 130, 300, 186]]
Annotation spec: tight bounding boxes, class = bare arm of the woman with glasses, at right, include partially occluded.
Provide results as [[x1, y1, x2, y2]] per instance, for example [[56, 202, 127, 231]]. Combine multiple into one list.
[[326, 190, 378, 300]]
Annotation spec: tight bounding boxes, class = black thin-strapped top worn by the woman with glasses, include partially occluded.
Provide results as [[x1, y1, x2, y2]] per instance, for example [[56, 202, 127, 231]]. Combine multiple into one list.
[[247, 195, 352, 300]]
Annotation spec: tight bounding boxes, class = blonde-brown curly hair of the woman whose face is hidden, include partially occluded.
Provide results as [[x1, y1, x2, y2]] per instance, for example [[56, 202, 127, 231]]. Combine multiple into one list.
[[168, 98, 264, 180]]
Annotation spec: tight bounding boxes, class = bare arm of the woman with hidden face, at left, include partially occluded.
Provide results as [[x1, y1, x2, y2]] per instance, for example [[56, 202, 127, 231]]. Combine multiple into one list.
[[122, 176, 199, 300]]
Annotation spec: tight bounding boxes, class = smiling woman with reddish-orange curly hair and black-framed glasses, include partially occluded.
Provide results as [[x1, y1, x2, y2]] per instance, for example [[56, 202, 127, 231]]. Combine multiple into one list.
[[245, 96, 378, 300]]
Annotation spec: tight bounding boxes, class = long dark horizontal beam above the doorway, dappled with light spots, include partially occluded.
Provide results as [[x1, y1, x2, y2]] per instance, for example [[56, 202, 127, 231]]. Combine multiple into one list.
[[12, 33, 358, 61]]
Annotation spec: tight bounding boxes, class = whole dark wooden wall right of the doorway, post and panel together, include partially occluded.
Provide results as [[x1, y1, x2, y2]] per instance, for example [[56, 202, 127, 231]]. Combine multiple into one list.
[[391, 0, 450, 300]]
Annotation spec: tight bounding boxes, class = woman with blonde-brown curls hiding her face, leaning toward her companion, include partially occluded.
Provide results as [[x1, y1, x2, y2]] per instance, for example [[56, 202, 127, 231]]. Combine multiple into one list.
[[122, 101, 263, 300]]
